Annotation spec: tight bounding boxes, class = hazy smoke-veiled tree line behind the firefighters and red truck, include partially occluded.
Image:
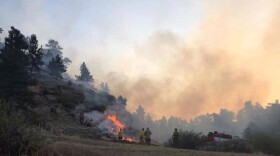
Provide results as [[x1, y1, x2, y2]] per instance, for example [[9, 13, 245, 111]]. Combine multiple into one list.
[[133, 100, 280, 142]]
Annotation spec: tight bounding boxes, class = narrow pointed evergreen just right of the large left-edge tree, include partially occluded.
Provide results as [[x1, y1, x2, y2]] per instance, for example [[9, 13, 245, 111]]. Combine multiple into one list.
[[28, 34, 44, 73]]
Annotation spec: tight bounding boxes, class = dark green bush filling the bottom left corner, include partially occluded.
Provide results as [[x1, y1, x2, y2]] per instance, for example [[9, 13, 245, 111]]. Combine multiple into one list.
[[0, 101, 50, 155]]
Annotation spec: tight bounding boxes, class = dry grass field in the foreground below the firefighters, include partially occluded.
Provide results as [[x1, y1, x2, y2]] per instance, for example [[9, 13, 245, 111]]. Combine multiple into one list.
[[37, 137, 266, 156]]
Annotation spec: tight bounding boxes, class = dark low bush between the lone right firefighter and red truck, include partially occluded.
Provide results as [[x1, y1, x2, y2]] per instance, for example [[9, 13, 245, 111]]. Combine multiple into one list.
[[165, 130, 205, 149]]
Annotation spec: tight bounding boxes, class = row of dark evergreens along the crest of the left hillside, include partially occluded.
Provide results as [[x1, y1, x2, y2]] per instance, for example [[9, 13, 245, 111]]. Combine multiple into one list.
[[0, 27, 93, 94]]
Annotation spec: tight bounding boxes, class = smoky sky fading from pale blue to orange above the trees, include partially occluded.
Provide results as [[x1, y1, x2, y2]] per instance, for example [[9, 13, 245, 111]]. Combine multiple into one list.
[[0, 0, 280, 119]]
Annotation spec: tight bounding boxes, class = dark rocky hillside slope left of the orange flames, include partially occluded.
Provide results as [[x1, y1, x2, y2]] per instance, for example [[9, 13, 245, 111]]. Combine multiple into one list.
[[25, 73, 108, 138]]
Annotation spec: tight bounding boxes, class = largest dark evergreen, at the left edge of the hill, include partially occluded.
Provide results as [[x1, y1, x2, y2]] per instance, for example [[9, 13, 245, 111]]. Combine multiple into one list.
[[0, 27, 32, 102]]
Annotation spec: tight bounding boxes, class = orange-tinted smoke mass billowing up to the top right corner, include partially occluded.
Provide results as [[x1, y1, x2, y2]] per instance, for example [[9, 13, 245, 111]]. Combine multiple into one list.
[[106, 1, 280, 119]]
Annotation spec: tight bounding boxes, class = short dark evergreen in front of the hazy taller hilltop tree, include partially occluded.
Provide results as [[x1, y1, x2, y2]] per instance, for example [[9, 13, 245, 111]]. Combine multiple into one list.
[[48, 55, 66, 79]]
